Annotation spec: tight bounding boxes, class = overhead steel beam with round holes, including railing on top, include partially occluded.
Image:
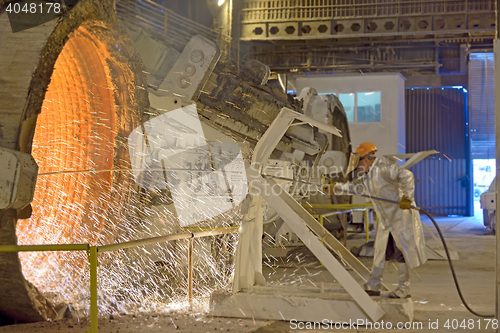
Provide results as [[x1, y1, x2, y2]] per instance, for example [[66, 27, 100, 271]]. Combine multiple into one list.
[[241, 0, 495, 40]]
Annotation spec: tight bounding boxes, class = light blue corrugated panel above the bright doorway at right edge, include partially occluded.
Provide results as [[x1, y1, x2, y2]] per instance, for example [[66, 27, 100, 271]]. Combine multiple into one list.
[[469, 52, 495, 158]]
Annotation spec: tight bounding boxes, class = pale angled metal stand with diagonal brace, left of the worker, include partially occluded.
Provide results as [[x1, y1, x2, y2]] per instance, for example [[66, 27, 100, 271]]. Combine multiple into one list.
[[227, 108, 387, 321]]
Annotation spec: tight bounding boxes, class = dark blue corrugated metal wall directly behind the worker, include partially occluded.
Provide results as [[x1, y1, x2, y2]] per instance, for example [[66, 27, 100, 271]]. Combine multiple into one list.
[[405, 88, 473, 216]]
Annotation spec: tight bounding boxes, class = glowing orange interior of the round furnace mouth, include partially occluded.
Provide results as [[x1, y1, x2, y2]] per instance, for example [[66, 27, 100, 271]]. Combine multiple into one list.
[[16, 29, 117, 291]]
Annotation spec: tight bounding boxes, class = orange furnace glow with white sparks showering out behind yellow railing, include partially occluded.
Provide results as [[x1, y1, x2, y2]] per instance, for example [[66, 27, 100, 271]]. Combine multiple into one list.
[[17, 28, 241, 316]]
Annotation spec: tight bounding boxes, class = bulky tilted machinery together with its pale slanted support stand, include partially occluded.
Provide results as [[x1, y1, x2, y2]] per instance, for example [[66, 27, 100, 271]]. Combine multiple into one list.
[[118, 31, 418, 321]]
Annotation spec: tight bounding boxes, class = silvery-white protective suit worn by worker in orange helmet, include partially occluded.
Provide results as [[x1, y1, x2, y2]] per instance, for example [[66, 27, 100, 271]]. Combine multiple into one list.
[[335, 158, 427, 294]]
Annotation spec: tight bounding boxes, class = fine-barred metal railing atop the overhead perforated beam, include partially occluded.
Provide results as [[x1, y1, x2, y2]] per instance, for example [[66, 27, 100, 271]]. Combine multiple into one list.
[[241, 0, 495, 23]]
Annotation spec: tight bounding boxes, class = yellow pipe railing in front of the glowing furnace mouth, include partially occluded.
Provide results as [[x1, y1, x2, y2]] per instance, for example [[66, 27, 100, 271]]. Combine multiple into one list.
[[0, 227, 238, 333]]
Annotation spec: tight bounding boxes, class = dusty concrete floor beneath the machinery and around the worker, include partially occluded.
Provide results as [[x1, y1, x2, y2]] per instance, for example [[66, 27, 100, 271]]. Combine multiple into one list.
[[0, 217, 495, 333]]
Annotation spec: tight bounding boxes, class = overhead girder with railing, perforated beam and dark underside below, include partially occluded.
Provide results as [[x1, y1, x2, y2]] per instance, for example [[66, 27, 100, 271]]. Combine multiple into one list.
[[239, 0, 495, 77]]
